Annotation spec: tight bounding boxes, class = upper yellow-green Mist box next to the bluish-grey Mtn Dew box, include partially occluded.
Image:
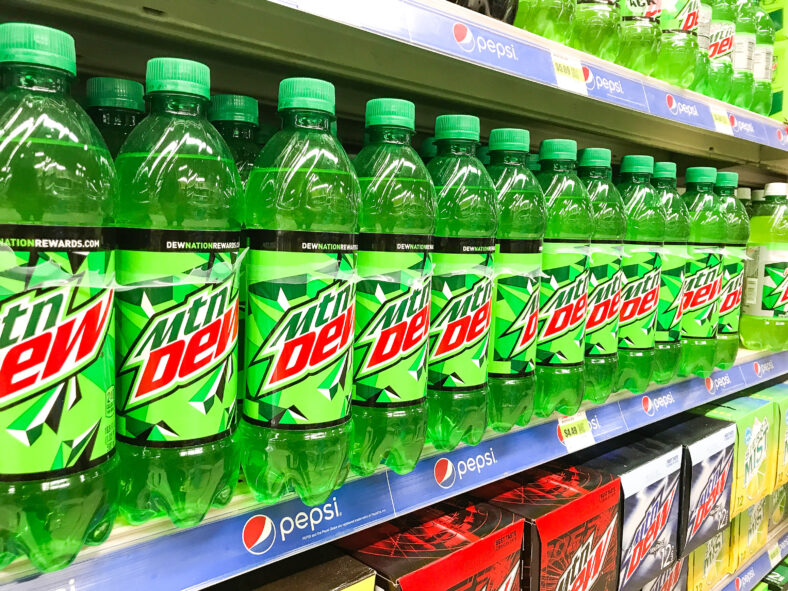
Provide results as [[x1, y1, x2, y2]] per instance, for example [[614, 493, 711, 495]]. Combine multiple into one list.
[[692, 397, 776, 519]]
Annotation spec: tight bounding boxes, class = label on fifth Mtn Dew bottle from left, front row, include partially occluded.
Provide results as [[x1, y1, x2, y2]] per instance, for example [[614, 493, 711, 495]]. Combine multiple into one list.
[[427, 236, 495, 391]]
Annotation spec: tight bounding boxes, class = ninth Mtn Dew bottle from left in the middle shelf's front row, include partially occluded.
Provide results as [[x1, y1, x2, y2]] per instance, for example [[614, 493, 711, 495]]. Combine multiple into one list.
[[616, 156, 665, 394]]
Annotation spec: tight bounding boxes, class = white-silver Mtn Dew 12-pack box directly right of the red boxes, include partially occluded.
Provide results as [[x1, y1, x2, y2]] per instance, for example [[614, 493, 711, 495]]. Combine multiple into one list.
[[583, 438, 682, 591]]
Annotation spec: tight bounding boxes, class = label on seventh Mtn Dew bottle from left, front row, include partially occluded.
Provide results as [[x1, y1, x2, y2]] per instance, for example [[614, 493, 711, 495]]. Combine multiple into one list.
[[536, 240, 589, 366]]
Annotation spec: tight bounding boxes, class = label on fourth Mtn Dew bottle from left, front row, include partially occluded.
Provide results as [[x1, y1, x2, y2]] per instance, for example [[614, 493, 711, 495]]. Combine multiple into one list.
[[353, 234, 432, 406]]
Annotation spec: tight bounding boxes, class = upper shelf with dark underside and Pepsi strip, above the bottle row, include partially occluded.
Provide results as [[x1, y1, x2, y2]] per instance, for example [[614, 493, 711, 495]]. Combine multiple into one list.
[[4, 0, 788, 181]]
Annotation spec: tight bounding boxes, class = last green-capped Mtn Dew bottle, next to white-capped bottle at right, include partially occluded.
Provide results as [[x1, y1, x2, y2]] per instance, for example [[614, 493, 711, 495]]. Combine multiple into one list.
[[714, 172, 750, 369]]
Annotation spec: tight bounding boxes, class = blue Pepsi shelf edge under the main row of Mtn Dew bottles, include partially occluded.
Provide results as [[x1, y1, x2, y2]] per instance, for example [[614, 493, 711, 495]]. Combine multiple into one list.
[[0, 351, 788, 591]]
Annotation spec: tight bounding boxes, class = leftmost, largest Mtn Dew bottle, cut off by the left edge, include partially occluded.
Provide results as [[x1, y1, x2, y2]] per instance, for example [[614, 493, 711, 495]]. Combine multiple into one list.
[[0, 23, 118, 571]]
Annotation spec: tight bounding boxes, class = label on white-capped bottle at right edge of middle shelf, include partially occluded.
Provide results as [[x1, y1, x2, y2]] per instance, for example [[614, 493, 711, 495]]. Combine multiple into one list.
[[744, 244, 788, 318]]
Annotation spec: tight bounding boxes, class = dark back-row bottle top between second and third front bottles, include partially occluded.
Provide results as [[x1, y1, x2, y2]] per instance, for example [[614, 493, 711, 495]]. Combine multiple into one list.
[[208, 94, 260, 185]]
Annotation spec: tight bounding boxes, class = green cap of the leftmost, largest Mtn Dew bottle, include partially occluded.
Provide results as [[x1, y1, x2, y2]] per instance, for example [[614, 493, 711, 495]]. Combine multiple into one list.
[[0, 23, 77, 76]]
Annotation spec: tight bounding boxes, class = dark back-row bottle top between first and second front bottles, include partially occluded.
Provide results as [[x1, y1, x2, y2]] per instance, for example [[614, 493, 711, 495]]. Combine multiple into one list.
[[85, 78, 145, 158]]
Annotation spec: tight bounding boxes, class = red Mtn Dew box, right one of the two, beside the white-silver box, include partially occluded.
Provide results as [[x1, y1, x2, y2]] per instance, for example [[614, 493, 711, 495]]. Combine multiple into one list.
[[473, 464, 620, 591]]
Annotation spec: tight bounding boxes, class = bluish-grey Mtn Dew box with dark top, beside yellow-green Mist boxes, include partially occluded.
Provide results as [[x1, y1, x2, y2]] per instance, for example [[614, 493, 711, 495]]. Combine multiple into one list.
[[649, 415, 736, 556]]
